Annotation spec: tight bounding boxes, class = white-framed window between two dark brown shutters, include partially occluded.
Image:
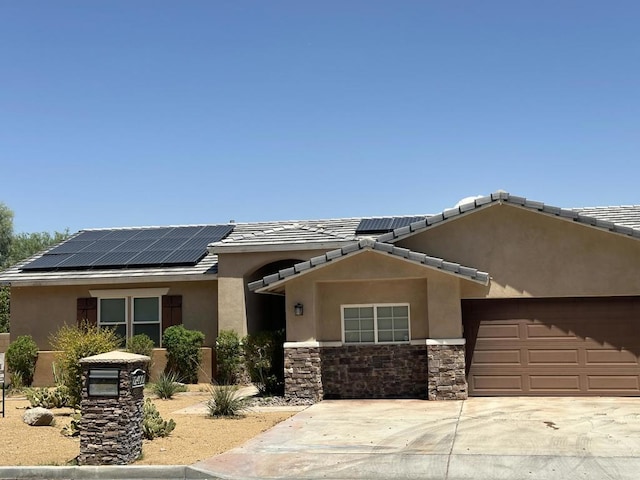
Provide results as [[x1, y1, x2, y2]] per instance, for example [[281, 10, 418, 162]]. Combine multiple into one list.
[[91, 288, 168, 347]]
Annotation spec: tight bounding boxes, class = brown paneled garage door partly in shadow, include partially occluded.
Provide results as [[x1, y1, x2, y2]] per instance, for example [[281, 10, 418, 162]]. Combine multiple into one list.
[[462, 297, 640, 396]]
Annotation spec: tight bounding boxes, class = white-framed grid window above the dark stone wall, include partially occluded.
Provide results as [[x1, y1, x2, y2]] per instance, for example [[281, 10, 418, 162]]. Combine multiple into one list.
[[341, 303, 411, 343]]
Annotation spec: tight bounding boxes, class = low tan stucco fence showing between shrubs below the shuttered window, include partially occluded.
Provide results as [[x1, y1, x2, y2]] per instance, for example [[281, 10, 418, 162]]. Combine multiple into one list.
[[23, 346, 215, 387]]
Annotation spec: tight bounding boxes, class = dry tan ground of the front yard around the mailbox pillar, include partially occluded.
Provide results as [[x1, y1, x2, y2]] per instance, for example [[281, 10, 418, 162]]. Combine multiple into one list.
[[0, 386, 295, 465]]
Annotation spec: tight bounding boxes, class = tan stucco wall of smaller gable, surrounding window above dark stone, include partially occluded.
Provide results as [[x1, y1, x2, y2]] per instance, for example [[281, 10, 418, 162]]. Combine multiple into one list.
[[286, 252, 466, 342]]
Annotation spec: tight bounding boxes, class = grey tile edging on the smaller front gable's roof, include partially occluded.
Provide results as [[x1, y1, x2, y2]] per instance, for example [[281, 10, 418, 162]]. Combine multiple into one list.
[[249, 238, 489, 291]]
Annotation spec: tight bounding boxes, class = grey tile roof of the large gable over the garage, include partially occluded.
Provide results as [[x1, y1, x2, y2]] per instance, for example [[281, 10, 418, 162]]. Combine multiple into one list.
[[378, 191, 640, 243]]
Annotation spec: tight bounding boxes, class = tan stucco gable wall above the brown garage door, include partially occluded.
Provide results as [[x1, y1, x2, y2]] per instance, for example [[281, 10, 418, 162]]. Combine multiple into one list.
[[398, 204, 640, 298]]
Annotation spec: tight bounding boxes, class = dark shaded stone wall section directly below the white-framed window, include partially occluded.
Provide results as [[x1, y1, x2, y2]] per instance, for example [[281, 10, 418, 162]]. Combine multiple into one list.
[[320, 345, 428, 398]]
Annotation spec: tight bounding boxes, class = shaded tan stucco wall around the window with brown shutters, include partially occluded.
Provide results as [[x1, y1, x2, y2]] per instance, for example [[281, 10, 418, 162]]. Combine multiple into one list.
[[11, 281, 218, 350]]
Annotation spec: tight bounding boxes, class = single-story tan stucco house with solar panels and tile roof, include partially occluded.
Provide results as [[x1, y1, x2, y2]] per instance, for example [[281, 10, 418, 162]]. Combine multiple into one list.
[[0, 191, 640, 400]]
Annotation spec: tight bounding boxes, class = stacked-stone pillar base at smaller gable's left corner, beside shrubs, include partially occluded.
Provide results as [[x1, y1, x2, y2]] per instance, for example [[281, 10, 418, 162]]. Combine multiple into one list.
[[284, 347, 324, 402]]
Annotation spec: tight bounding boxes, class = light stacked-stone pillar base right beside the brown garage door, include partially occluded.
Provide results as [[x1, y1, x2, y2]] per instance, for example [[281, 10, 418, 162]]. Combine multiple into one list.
[[427, 345, 468, 400]]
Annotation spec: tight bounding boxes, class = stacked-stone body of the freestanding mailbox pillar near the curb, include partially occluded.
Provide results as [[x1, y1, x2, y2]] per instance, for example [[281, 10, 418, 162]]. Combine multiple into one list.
[[78, 362, 145, 465]]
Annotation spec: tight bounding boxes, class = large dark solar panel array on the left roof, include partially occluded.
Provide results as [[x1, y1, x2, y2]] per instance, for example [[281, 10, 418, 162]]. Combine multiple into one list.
[[22, 225, 239, 270]]
